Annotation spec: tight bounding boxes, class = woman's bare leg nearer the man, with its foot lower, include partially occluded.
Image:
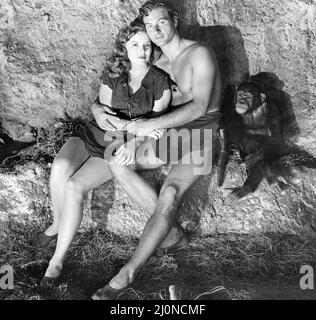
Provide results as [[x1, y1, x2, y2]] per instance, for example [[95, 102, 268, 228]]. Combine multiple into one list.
[[45, 157, 113, 278]]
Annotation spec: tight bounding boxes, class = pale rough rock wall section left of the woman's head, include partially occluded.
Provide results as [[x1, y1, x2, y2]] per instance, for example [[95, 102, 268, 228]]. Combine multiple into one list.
[[0, 0, 143, 136]]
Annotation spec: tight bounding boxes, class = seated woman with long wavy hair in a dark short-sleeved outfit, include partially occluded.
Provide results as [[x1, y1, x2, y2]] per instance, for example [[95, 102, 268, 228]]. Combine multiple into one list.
[[34, 24, 171, 286]]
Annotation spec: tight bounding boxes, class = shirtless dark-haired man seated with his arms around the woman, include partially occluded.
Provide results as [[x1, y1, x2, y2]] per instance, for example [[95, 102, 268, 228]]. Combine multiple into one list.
[[92, 0, 222, 300]]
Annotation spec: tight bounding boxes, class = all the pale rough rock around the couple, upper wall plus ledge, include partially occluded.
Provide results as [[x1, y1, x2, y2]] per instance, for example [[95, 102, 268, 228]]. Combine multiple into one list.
[[0, 0, 316, 236]]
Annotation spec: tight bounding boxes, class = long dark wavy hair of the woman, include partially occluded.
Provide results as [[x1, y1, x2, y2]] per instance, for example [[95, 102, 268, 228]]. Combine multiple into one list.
[[104, 18, 159, 78]]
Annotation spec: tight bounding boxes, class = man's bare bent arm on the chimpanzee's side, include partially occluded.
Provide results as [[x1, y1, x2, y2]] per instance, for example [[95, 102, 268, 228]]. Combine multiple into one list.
[[147, 46, 216, 129]]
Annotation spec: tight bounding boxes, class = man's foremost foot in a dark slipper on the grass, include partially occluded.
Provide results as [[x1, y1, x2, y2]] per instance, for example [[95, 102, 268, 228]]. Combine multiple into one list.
[[91, 266, 135, 300]]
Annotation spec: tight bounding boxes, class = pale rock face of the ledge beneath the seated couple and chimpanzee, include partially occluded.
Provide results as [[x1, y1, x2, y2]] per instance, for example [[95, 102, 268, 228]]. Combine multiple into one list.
[[0, 162, 316, 237]]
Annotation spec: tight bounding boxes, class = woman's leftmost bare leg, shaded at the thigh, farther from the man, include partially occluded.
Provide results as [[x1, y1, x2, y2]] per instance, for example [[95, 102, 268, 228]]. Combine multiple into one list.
[[45, 137, 89, 236]]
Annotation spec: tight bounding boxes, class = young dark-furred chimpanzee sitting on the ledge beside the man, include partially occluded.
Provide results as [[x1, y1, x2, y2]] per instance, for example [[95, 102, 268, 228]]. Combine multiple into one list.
[[225, 83, 287, 204]]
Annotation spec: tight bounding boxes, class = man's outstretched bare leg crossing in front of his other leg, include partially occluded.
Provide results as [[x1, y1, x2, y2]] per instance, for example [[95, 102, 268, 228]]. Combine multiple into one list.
[[92, 164, 199, 300]]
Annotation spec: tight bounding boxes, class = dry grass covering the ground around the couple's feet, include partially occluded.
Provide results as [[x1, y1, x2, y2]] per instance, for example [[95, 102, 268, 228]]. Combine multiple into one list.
[[0, 220, 316, 300]]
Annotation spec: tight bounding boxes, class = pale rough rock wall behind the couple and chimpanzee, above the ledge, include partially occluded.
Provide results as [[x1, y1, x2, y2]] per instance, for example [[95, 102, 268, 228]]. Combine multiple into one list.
[[0, 0, 316, 154]]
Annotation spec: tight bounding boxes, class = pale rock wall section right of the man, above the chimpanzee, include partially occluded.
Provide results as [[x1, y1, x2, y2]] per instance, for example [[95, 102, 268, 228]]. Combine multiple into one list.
[[188, 0, 316, 153]]
